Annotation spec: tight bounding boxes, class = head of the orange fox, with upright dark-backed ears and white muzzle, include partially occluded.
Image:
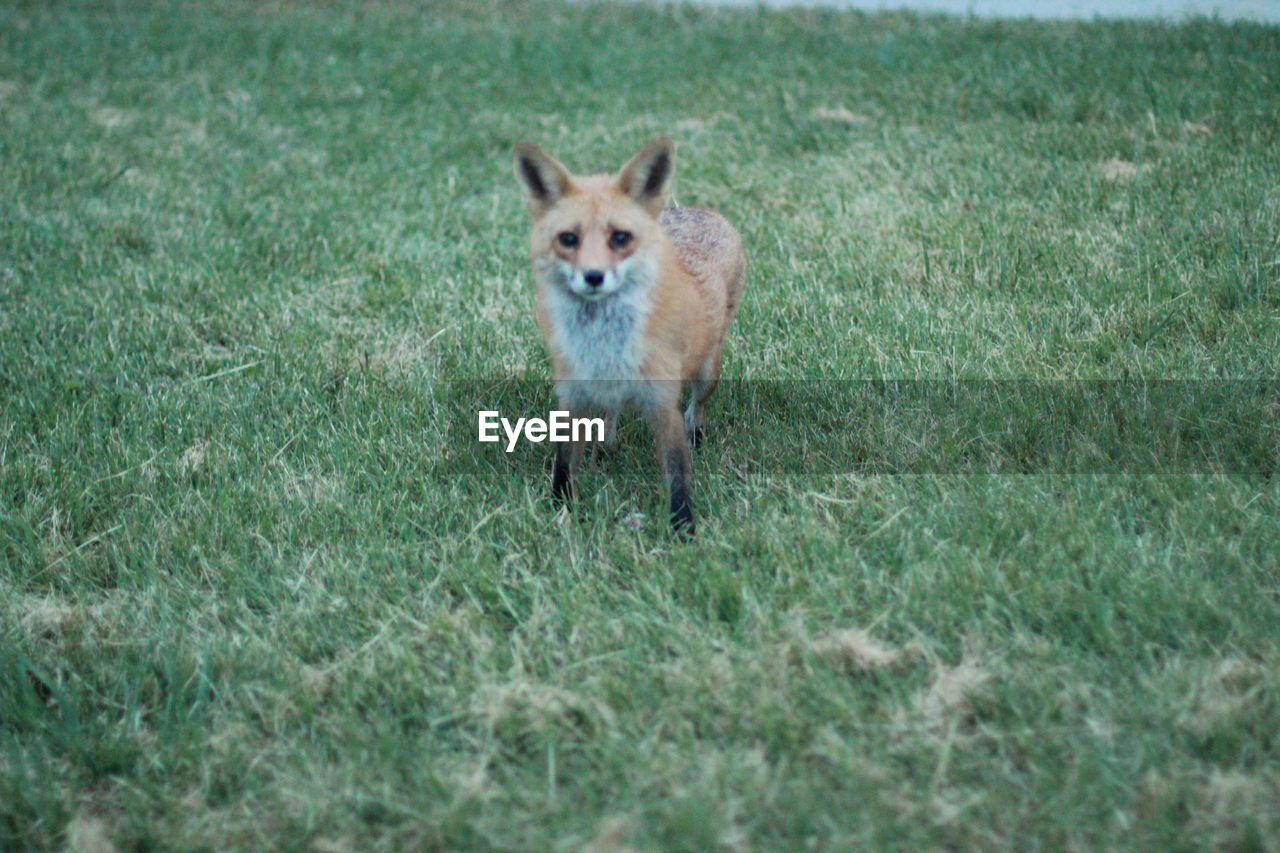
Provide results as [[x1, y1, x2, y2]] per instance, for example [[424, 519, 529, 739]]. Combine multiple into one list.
[[513, 136, 675, 301]]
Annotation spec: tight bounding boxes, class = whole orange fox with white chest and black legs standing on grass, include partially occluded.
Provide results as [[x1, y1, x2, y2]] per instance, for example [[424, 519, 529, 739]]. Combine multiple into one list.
[[512, 136, 746, 537]]
